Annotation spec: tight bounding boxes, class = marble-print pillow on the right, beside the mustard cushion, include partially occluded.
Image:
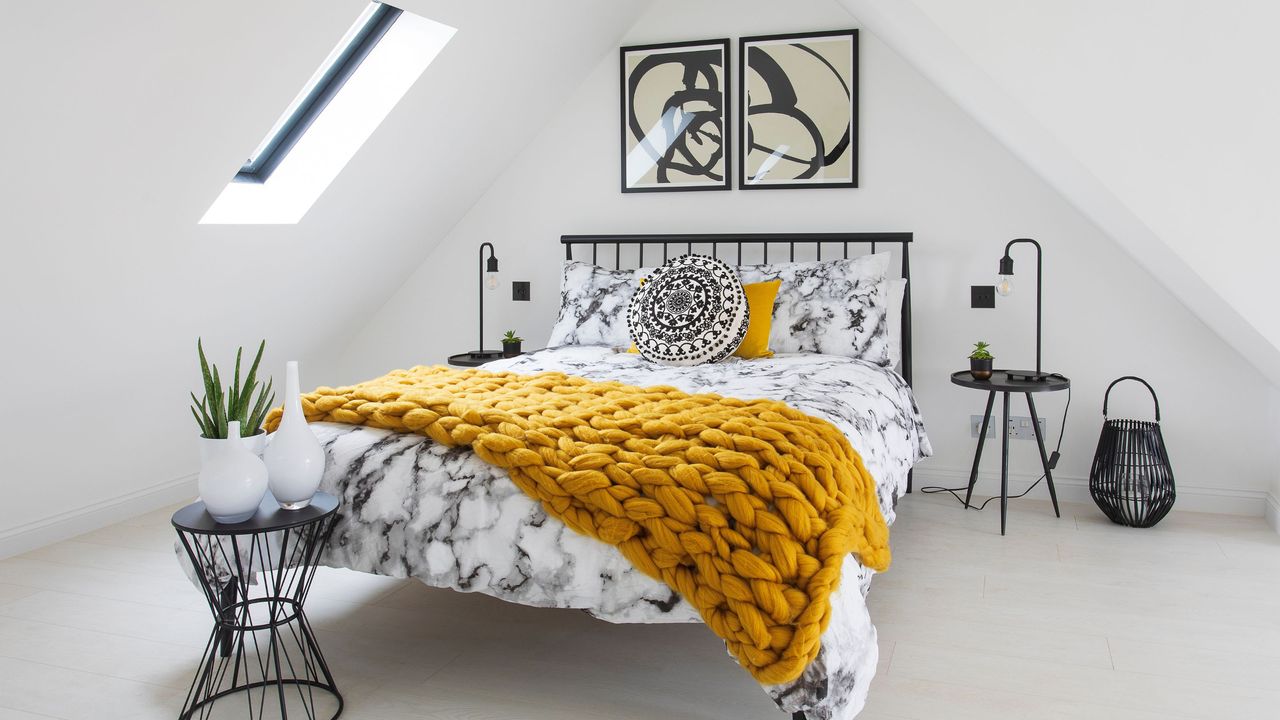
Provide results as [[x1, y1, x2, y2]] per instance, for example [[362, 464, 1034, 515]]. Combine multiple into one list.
[[739, 252, 891, 366]]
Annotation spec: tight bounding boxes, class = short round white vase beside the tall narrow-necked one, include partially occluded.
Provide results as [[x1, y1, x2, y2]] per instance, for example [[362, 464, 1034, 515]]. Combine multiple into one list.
[[200, 420, 266, 523]]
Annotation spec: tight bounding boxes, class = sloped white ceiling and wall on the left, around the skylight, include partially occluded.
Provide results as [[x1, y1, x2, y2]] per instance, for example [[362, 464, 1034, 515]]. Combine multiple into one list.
[[0, 0, 644, 539]]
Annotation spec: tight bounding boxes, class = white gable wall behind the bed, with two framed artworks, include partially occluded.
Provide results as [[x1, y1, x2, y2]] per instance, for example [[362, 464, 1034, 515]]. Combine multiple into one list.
[[337, 0, 1275, 514]]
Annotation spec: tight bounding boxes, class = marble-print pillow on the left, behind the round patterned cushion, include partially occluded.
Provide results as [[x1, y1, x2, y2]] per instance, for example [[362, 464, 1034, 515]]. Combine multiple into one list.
[[547, 260, 636, 347]]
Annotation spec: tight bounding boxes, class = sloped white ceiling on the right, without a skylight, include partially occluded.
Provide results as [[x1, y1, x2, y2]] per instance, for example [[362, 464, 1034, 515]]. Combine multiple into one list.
[[841, 0, 1280, 383]]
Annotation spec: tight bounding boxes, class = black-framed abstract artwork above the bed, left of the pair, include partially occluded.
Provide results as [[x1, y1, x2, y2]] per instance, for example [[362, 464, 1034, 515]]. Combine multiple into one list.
[[621, 40, 732, 192]]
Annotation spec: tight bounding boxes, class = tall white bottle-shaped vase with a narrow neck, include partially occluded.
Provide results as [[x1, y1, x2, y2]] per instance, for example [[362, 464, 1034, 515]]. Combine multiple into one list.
[[262, 360, 325, 510]]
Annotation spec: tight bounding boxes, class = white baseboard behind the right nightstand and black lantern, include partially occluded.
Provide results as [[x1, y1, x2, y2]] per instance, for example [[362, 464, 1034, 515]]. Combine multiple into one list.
[[913, 464, 1280, 515]]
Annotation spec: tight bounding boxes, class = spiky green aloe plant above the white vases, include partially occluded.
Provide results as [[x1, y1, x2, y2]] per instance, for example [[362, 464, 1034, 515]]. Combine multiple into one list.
[[191, 340, 275, 439]]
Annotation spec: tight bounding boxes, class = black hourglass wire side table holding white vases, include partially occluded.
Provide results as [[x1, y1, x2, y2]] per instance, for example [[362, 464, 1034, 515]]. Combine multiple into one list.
[[173, 492, 343, 720]]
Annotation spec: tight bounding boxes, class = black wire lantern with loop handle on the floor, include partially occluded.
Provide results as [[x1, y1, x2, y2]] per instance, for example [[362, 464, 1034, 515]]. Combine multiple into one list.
[[1089, 375, 1178, 528]]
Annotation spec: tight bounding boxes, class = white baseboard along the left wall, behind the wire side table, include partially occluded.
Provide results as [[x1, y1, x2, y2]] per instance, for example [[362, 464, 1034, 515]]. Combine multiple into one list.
[[0, 474, 196, 559]]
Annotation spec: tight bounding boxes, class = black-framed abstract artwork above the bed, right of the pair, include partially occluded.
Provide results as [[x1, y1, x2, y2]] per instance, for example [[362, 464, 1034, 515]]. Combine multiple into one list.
[[737, 29, 858, 190]]
